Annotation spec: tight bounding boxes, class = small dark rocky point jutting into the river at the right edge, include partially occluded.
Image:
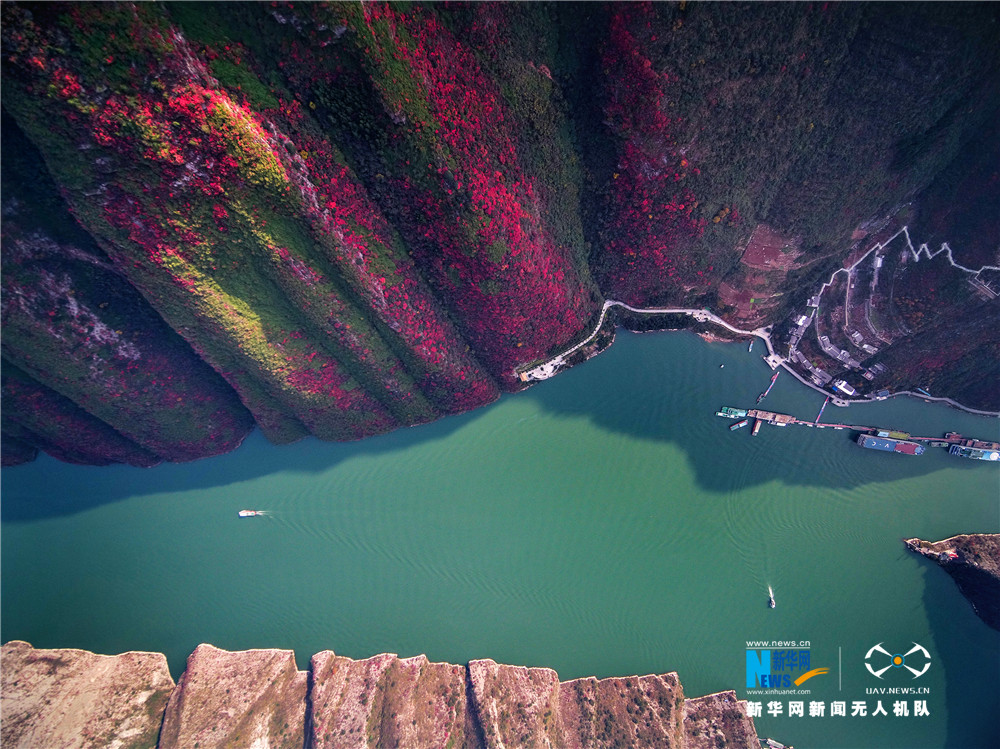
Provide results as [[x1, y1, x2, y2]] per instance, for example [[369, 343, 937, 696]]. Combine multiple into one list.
[[904, 533, 1000, 630]]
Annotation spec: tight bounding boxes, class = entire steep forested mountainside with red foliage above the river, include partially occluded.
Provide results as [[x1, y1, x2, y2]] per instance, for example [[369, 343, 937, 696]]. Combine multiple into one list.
[[2, 2, 1000, 465]]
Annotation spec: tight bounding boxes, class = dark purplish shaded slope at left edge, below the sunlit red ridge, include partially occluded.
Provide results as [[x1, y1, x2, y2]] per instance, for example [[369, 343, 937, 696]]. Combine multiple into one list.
[[0, 106, 253, 465]]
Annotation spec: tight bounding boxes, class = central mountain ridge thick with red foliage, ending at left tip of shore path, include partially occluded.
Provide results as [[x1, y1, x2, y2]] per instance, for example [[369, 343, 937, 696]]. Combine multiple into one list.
[[342, 3, 592, 381]]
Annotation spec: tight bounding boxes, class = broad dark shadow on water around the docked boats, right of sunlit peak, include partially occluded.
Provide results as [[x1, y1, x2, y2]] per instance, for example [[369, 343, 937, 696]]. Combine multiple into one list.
[[522, 330, 1000, 492]]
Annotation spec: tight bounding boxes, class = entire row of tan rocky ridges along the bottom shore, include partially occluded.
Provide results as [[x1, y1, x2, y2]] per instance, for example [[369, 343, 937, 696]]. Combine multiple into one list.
[[0, 641, 759, 749]]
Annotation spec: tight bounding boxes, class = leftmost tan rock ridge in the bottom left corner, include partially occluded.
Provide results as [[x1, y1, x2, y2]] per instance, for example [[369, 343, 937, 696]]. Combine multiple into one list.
[[0, 640, 174, 749]]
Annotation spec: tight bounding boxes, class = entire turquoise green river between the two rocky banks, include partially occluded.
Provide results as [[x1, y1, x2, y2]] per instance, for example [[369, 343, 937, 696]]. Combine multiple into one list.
[[2, 333, 1000, 748]]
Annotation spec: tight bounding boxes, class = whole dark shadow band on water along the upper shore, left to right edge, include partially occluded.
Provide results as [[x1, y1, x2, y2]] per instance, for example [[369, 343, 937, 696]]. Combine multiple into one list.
[[0, 330, 1000, 522]]
